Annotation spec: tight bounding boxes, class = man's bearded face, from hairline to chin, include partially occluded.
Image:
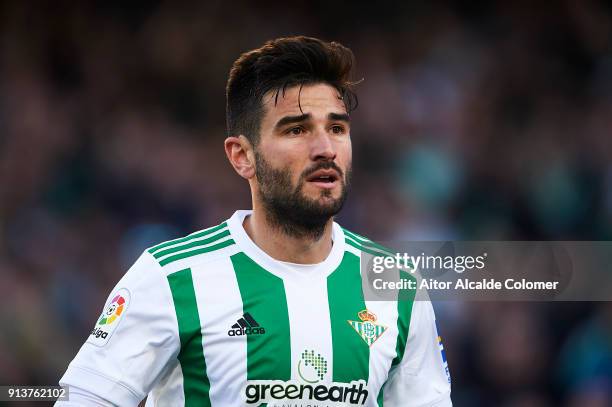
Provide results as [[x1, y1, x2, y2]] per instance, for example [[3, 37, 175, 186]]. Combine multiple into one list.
[[255, 84, 351, 235]]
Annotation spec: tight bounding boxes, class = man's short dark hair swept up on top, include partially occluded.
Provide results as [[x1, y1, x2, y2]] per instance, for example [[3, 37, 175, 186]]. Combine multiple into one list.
[[226, 36, 357, 145]]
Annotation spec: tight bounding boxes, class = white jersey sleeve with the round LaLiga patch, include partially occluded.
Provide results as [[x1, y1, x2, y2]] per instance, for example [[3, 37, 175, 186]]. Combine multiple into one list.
[[60, 252, 180, 406]]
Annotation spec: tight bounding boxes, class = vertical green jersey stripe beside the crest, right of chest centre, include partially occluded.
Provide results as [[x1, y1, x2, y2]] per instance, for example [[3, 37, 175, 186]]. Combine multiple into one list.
[[327, 252, 370, 383]]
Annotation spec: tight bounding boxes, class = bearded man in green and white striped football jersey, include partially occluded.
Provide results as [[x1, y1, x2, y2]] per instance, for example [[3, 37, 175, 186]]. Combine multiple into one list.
[[60, 37, 451, 406]]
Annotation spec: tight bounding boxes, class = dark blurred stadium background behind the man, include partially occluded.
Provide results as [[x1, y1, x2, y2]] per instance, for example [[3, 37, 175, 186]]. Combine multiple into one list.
[[0, 0, 612, 407]]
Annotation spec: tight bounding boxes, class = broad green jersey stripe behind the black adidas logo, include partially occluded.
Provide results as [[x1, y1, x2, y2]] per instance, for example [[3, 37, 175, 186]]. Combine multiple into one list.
[[231, 252, 294, 380]]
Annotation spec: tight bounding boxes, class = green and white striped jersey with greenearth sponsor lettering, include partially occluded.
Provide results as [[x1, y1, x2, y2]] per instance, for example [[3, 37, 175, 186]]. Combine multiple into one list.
[[60, 211, 451, 407]]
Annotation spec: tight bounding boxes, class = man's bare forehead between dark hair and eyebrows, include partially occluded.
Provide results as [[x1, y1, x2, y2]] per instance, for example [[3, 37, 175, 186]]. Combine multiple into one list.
[[263, 83, 346, 121]]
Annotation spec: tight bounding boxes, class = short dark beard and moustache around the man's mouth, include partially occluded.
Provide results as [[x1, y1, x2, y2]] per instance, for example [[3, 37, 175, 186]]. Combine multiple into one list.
[[255, 151, 351, 241]]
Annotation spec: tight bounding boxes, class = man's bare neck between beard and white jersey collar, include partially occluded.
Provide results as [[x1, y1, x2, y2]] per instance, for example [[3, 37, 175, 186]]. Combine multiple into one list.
[[243, 205, 333, 264]]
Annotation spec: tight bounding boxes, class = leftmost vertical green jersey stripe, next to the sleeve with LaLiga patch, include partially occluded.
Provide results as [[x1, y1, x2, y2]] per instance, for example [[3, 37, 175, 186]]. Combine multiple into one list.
[[168, 269, 210, 407]]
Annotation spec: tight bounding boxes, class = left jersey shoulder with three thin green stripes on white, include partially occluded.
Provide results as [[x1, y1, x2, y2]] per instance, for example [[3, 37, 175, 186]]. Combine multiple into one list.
[[145, 221, 236, 274]]
